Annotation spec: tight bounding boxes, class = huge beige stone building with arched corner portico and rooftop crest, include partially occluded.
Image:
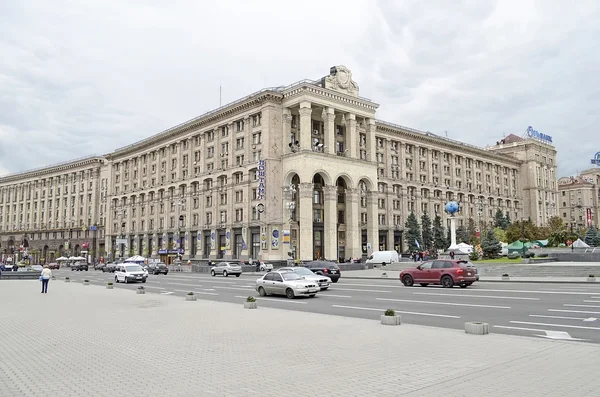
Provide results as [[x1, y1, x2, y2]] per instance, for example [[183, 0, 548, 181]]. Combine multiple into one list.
[[0, 66, 558, 261]]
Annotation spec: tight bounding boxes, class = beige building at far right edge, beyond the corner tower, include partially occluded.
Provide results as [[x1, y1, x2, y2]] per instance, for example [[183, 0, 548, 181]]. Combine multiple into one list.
[[558, 168, 600, 231]]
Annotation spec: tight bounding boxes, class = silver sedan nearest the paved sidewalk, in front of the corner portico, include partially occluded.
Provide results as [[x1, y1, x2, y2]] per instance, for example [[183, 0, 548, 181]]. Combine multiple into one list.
[[256, 272, 319, 299]]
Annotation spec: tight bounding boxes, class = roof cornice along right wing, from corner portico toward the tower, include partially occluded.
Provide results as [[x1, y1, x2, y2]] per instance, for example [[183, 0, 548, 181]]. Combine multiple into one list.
[[376, 120, 522, 166]]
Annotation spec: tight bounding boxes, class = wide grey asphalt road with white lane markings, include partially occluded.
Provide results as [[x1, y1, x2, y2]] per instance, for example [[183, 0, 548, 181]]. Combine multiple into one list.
[[56, 270, 600, 343]]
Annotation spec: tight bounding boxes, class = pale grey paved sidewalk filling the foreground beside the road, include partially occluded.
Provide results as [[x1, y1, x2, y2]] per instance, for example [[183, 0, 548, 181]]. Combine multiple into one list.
[[0, 281, 600, 397]]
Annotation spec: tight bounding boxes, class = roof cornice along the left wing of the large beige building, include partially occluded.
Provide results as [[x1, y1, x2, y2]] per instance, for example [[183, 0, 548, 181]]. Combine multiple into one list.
[[106, 88, 283, 160]]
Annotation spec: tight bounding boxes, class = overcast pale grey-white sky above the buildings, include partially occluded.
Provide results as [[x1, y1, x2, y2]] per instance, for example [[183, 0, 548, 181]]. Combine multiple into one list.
[[0, 0, 600, 176]]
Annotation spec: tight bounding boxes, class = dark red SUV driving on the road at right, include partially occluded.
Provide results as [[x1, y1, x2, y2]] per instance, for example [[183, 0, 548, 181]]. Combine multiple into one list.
[[400, 259, 478, 288]]
